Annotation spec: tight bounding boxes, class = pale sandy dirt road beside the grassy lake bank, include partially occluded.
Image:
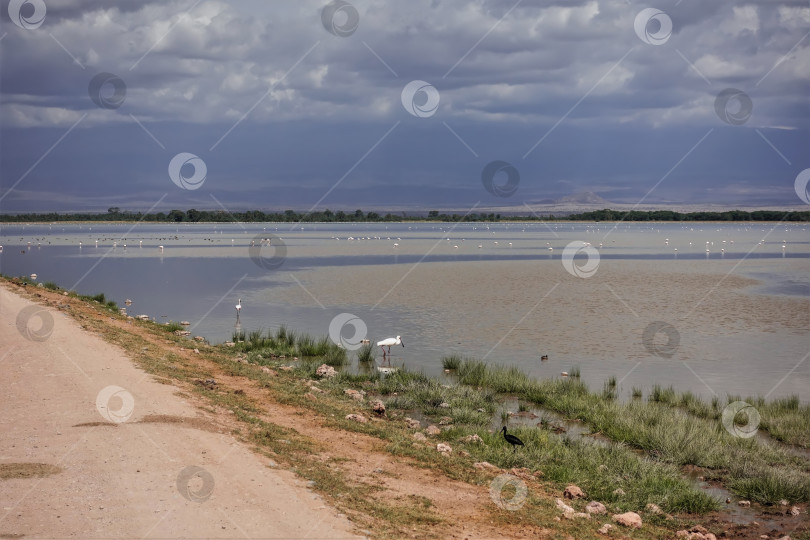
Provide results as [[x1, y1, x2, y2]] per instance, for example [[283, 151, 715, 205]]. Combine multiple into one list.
[[0, 287, 354, 538]]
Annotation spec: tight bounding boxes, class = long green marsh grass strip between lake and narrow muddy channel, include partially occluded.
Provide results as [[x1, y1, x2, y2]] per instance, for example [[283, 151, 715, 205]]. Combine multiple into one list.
[[458, 360, 810, 504]]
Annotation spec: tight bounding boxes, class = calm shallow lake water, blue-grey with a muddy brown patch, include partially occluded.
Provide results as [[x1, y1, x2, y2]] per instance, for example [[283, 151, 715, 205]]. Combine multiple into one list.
[[0, 219, 810, 401]]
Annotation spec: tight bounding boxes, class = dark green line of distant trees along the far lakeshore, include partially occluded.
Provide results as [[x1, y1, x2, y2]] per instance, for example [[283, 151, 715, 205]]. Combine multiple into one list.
[[0, 207, 810, 223]]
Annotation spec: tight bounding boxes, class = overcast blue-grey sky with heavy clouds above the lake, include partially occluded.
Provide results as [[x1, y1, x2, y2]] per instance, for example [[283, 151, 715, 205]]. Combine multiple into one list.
[[0, 0, 810, 212]]
